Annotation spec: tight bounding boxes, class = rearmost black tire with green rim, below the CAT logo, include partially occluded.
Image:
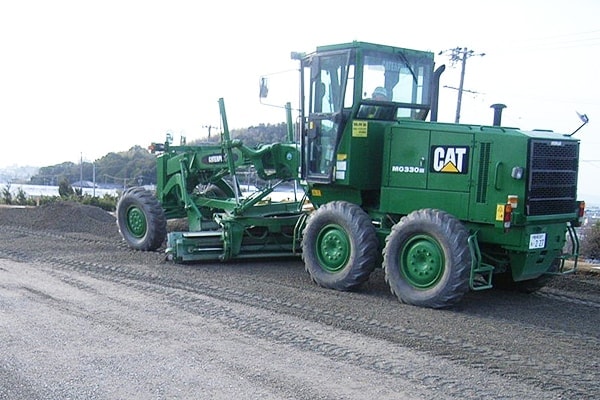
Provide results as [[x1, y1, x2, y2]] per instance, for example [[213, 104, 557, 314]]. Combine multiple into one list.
[[383, 209, 471, 308]]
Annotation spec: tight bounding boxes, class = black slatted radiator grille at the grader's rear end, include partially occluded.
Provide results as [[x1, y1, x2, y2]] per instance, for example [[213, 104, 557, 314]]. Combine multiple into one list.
[[527, 140, 579, 215]]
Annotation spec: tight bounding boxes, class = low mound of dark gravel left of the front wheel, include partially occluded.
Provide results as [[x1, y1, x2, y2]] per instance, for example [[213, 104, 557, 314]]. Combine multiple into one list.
[[0, 201, 119, 236]]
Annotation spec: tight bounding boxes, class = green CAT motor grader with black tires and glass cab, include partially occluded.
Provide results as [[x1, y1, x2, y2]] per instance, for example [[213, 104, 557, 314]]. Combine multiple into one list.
[[117, 42, 585, 308]]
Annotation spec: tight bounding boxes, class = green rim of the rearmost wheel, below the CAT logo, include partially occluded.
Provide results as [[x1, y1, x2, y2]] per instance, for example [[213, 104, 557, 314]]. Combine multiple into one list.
[[400, 235, 445, 289]]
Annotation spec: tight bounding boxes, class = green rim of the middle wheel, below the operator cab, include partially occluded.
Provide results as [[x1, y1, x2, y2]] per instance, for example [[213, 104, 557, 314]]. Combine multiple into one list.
[[317, 224, 351, 272]]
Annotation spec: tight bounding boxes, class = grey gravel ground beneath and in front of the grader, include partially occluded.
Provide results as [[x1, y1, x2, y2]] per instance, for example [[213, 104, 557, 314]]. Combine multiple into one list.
[[0, 203, 600, 400]]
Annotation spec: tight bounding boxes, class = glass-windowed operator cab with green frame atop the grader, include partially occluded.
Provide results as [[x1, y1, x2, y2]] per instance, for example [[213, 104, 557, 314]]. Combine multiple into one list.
[[298, 42, 441, 183]]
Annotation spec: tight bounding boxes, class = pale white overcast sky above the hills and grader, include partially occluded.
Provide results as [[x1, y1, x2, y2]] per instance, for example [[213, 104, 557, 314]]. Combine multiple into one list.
[[0, 0, 600, 199]]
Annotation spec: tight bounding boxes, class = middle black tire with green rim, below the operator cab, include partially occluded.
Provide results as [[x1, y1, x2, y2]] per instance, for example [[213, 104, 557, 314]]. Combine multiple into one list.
[[302, 201, 379, 290]]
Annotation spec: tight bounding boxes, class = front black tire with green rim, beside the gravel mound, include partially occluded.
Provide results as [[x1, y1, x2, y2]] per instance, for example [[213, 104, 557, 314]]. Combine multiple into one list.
[[117, 187, 167, 251]]
